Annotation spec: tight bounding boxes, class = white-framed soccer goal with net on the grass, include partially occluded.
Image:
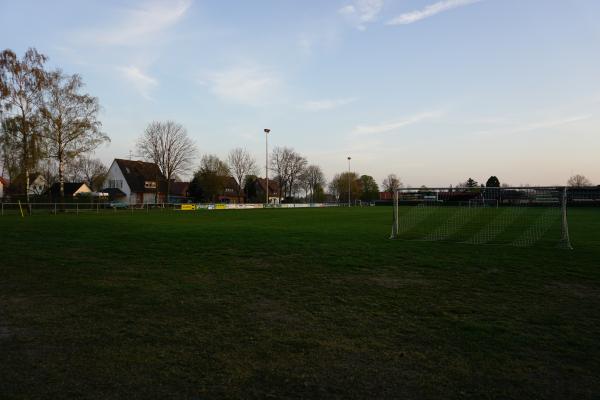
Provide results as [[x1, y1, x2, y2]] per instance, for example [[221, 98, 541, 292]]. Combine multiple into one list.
[[391, 187, 572, 249]]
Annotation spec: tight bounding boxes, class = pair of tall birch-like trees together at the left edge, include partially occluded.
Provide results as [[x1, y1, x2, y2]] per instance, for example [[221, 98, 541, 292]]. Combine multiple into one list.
[[0, 48, 110, 202]]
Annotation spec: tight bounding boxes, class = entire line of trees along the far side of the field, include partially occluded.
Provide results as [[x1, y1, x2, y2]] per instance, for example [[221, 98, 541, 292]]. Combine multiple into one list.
[[5, 48, 591, 202]]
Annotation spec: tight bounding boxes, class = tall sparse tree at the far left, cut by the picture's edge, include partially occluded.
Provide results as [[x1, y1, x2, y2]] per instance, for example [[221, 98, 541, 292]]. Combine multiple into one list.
[[0, 48, 47, 203]]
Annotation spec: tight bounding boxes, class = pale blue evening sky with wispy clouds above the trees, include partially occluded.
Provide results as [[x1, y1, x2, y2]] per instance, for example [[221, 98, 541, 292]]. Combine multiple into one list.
[[0, 0, 600, 187]]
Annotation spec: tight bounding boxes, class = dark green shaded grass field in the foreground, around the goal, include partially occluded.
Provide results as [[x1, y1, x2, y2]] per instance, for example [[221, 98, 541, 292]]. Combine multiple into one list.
[[0, 207, 600, 399]]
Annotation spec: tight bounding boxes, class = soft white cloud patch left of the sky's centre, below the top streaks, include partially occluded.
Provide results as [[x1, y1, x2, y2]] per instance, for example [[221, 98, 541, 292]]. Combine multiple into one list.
[[199, 65, 283, 106]]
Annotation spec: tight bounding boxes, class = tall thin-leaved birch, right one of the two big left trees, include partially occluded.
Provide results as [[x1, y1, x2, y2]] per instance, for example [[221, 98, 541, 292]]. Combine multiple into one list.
[[41, 70, 110, 197]]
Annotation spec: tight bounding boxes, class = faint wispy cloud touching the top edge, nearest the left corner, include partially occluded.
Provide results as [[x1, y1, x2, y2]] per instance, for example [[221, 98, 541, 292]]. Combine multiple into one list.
[[83, 0, 191, 45]]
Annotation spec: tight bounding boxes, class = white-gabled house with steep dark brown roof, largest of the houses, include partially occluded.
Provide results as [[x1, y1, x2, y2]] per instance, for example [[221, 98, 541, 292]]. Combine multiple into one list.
[[102, 158, 167, 204]]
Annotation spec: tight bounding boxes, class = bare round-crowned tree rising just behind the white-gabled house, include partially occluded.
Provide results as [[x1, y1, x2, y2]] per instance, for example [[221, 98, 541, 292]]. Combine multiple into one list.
[[137, 121, 196, 197]]
